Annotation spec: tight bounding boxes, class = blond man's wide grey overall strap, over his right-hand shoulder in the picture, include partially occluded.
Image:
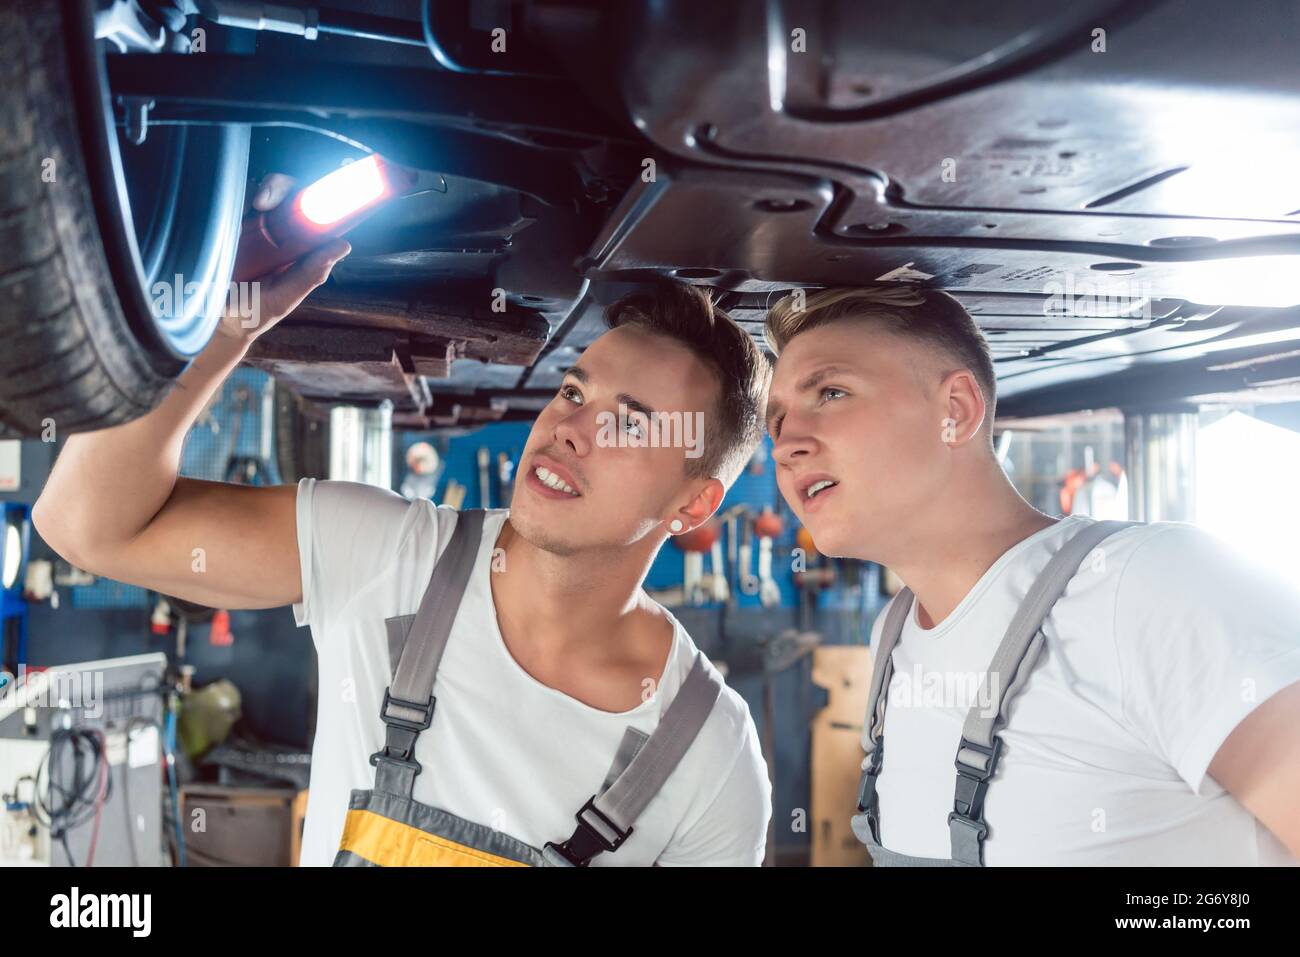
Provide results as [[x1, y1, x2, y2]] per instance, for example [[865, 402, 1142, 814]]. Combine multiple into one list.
[[948, 521, 1140, 867]]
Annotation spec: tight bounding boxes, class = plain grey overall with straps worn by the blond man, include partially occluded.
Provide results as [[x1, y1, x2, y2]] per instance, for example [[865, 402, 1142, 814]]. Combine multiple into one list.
[[850, 521, 1139, 867]]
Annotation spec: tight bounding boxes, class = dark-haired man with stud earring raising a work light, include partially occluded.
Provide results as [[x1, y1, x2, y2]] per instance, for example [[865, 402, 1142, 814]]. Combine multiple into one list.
[[34, 175, 771, 866]]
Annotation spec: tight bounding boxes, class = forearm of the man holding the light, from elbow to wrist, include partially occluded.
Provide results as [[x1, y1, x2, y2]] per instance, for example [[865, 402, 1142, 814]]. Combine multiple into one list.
[[33, 332, 248, 558]]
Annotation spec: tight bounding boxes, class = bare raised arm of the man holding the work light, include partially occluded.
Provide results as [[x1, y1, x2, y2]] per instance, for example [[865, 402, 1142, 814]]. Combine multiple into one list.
[[31, 178, 351, 609]]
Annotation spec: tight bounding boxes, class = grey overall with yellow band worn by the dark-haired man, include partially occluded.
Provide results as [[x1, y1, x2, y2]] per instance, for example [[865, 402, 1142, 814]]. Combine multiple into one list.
[[334, 510, 722, 867]]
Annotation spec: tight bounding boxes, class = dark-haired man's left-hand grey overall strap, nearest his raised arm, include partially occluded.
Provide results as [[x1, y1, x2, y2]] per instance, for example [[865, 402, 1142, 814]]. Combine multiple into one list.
[[371, 508, 484, 797]]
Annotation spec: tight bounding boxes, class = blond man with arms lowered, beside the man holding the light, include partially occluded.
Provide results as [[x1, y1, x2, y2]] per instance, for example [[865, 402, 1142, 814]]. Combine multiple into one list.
[[767, 285, 1300, 866]]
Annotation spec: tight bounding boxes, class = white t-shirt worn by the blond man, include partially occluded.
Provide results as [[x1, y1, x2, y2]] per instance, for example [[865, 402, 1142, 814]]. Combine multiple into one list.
[[863, 516, 1300, 866]]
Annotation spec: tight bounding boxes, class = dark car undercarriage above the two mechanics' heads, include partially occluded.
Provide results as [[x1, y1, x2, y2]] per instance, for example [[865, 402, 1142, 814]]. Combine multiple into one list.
[[4, 0, 1300, 432]]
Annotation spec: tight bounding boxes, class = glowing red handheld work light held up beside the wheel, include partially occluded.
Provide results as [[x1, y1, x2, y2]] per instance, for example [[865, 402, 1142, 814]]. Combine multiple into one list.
[[234, 153, 416, 282]]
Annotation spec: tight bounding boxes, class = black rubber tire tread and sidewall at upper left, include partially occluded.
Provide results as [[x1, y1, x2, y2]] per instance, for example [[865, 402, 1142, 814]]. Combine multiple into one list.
[[0, 0, 244, 437]]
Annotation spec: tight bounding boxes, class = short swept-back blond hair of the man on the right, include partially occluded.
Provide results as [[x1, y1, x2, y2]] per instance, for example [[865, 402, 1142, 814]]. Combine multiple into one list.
[[766, 282, 997, 442]]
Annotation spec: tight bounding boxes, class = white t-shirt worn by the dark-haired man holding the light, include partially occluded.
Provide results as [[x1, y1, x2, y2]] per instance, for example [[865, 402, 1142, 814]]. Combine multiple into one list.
[[294, 479, 771, 866]]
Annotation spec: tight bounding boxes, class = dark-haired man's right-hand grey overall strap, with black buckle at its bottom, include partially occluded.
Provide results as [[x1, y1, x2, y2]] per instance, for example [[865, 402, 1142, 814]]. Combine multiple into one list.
[[546, 651, 722, 867]]
